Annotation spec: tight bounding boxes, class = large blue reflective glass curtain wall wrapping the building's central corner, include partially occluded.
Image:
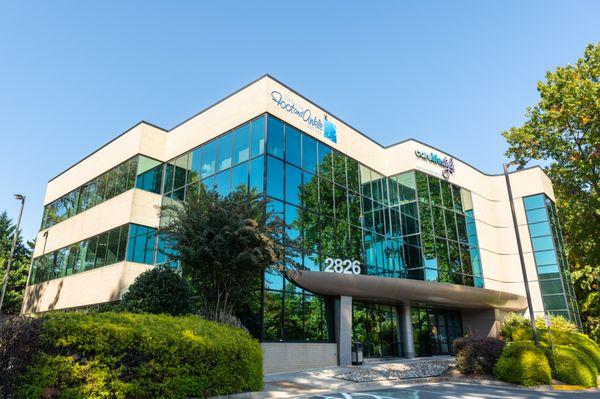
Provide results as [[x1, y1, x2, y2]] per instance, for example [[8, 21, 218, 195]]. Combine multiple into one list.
[[152, 114, 483, 341]]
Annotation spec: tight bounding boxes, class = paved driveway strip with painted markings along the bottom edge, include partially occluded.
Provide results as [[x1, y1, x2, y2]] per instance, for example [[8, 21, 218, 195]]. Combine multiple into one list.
[[302, 382, 600, 399]]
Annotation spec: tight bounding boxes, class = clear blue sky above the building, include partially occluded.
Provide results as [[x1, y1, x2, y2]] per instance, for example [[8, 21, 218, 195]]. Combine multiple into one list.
[[0, 0, 600, 239]]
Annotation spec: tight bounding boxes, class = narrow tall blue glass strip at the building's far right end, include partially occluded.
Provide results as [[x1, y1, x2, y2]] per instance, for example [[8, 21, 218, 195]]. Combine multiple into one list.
[[523, 194, 581, 328]]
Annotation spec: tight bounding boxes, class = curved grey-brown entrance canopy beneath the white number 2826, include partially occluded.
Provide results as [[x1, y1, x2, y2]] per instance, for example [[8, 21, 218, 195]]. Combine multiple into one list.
[[286, 270, 527, 312]]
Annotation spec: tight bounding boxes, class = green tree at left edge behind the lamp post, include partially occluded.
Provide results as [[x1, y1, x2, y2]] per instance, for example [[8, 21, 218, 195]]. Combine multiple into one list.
[[0, 211, 33, 314]]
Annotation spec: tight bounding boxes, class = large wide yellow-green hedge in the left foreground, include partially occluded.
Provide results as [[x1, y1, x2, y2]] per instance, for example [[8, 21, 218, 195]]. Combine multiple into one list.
[[5, 312, 262, 398]]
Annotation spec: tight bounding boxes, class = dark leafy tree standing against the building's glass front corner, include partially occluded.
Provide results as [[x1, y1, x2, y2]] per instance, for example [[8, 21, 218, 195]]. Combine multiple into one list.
[[161, 184, 285, 321]]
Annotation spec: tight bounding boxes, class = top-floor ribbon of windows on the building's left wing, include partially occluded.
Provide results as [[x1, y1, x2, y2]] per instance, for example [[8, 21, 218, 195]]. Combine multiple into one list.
[[41, 155, 162, 230]]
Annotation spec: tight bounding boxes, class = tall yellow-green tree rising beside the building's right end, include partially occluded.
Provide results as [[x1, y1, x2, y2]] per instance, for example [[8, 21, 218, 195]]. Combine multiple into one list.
[[502, 43, 600, 340]]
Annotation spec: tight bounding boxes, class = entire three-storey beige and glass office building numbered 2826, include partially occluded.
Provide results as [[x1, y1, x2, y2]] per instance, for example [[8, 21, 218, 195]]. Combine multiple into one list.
[[23, 76, 580, 372]]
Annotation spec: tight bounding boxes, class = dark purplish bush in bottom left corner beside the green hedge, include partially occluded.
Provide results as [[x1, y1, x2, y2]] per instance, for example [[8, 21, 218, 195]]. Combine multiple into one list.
[[0, 316, 41, 398]]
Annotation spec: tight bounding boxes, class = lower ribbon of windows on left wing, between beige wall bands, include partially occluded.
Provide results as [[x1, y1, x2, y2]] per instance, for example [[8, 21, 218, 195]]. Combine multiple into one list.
[[29, 224, 156, 284]]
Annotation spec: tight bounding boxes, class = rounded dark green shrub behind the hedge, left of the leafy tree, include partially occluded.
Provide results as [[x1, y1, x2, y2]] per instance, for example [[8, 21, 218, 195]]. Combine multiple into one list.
[[121, 266, 193, 316]]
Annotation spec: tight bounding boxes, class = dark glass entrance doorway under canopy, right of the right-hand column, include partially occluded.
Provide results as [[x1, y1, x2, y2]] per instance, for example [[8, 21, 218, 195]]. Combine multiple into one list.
[[411, 307, 462, 356]]
